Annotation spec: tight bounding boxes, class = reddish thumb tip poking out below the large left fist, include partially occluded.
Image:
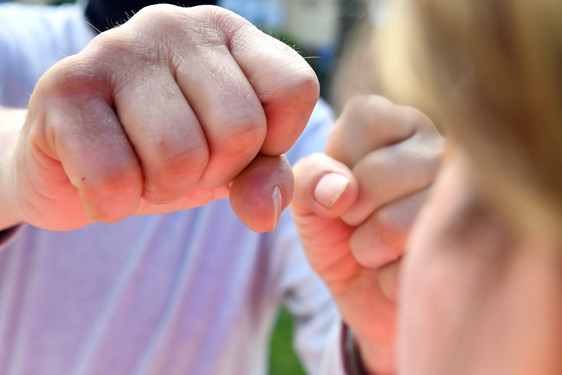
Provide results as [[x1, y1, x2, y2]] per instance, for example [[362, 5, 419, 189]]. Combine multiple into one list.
[[230, 155, 293, 232]]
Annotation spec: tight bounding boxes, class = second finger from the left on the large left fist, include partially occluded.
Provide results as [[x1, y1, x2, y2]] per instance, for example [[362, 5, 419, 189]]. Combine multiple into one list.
[[115, 65, 209, 204]]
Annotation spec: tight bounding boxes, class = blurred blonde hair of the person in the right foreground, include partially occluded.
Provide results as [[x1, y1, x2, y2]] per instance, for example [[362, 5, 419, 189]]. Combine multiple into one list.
[[375, 0, 562, 244]]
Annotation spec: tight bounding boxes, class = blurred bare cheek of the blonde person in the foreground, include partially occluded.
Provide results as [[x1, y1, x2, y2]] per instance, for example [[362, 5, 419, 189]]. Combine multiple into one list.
[[398, 146, 562, 375]]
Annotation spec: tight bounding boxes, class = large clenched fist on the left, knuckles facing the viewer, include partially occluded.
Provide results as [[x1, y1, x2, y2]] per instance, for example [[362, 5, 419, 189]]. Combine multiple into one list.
[[0, 5, 318, 231]]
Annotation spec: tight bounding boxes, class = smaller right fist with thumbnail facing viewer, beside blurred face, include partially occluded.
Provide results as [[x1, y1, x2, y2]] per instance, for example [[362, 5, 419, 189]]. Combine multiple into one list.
[[291, 96, 443, 374]]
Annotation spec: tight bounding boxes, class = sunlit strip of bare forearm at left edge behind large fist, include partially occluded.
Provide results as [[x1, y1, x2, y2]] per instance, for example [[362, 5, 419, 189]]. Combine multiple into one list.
[[0, 108, 27, 231]]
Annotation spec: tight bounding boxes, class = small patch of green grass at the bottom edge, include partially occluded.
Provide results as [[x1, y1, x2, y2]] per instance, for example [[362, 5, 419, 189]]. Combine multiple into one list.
[[269, 309, 304, 375]]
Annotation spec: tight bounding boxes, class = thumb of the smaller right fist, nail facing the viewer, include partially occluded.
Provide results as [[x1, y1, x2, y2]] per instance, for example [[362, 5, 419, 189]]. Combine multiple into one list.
[[293, 154, 358, 217]]
